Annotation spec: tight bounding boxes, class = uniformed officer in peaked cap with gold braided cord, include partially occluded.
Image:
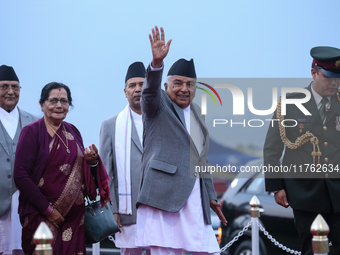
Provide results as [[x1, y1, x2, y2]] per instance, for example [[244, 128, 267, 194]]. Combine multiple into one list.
[[264, 47, 340, 255]]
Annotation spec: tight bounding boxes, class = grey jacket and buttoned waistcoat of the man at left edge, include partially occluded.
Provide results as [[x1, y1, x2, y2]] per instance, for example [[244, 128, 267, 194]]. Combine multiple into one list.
[[0, 108, 38, 216]]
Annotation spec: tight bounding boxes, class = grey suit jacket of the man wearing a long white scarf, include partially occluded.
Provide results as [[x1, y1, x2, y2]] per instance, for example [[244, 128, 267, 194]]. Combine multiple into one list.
[[99, 112, 142, 225]]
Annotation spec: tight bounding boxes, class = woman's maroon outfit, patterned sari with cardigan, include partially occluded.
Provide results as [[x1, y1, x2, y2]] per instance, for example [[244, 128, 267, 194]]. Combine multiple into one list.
[[14, 118, 110, 254]]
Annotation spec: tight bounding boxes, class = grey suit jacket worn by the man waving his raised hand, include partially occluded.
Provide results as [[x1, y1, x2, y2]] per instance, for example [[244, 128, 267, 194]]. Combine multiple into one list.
[[137, 67, 217, 224]]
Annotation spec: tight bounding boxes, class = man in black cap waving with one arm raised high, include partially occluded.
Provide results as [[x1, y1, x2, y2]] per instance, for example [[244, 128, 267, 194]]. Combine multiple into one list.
[[136, 27, 226, 254]]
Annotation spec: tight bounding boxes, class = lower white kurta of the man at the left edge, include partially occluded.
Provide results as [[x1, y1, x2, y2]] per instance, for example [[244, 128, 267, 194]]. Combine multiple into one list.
[[0, 191, 22, 254]]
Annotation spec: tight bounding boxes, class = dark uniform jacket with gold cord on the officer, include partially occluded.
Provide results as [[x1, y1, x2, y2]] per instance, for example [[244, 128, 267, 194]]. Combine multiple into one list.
[[264, 85, 340, 213]]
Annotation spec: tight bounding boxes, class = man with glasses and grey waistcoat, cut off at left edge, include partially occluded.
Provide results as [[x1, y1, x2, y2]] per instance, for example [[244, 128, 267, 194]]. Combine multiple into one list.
[[0, 65, 38, 255]]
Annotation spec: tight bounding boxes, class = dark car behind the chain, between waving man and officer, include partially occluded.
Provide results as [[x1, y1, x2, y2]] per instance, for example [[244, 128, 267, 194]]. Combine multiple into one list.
[[220, 159, 300, 255]]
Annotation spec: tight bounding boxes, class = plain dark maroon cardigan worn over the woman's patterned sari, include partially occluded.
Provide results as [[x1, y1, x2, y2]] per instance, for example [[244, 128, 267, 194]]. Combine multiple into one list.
[[13, 118, 110, 215]]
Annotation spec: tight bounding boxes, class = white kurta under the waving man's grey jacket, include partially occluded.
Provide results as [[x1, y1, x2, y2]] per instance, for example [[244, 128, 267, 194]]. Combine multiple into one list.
[[135, 106, 220, 253]]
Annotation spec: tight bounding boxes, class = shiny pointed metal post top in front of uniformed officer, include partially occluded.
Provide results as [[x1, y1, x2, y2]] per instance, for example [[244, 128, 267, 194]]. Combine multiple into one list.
[[310, 214, 329, 255]]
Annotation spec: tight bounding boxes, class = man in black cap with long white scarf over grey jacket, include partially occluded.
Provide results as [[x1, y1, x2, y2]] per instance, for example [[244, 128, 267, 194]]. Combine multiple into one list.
[[99, 62, 148, 255]]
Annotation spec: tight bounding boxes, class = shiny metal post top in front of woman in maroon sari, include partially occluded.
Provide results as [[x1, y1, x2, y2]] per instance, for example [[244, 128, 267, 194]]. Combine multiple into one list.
[[33, 222, 53, 255]]
